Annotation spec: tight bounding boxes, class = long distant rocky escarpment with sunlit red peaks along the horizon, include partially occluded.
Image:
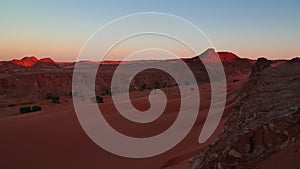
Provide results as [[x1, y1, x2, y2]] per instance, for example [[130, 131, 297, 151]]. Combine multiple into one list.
[[0, 49, 253, 103]]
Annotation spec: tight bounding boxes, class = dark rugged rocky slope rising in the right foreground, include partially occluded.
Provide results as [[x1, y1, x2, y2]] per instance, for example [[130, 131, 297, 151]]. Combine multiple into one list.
[[189, 59, 300, 169]]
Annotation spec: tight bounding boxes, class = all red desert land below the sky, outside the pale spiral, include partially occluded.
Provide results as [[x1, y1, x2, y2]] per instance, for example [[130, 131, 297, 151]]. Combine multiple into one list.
[[0, 49, 300, 169]]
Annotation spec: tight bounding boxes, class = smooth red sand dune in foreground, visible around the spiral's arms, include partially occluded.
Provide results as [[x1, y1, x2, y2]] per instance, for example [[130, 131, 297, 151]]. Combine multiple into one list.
[[0, 80, 244, 169]]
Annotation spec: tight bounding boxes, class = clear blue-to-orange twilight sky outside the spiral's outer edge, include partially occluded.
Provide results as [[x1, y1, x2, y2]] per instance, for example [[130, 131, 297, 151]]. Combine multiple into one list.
[[0, 0, 300, 61]]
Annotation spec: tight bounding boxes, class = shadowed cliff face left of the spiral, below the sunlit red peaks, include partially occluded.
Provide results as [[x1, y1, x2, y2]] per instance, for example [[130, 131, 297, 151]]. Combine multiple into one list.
[[0, 70, 72, 103]]
